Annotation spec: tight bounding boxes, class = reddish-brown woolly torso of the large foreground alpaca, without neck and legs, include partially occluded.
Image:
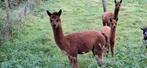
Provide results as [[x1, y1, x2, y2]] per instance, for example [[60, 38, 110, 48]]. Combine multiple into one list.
[[65, 31, 105, 54]]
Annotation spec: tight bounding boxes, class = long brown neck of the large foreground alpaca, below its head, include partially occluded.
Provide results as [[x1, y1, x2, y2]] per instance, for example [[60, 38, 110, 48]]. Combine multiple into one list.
[[53, 25, 67, 50]]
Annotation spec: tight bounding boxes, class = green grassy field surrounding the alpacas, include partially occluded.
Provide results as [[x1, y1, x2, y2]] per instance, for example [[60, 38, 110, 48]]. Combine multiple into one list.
[[0, 0, 147, 68]]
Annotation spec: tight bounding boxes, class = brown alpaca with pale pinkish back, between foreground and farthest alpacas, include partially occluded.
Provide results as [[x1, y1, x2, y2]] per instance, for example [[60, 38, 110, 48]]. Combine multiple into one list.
[[101, 19, 117, 56]]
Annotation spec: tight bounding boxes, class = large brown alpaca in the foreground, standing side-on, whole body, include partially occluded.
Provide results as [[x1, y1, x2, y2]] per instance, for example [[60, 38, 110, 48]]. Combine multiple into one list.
[[47, 10, 106, 68]]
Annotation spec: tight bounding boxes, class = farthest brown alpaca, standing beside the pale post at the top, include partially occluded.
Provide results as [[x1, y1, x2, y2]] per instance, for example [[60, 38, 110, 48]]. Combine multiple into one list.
[[102, 0, 122, 26]]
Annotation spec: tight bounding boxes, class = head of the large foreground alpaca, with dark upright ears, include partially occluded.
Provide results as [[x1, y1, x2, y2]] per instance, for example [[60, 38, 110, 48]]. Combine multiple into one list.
[[46, 9, 62, 29]]
